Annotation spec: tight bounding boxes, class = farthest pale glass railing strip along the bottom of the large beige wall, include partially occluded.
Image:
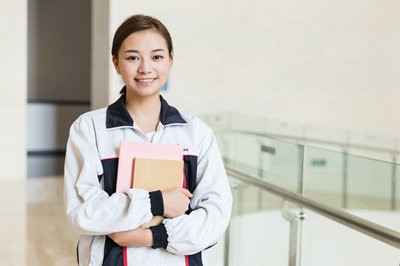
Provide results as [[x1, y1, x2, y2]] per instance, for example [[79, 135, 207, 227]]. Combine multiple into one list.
[[202, 113, 400, 162]]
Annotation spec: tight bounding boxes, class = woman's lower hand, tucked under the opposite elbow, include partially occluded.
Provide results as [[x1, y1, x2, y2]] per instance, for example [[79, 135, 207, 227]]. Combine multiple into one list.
[[108, 227, 154, 247]]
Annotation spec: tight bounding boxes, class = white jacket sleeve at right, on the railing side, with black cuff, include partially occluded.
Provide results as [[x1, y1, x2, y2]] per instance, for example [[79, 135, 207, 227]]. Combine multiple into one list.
[[151, 123, 232, 255]]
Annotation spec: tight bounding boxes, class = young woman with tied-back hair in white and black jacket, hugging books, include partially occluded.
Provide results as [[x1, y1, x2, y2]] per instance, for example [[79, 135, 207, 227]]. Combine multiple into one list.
[[65, 15, 232, 266]]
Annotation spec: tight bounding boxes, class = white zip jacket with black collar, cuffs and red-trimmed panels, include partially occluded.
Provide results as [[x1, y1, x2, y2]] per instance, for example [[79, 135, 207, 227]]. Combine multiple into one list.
[[64, 92, 232, 266]]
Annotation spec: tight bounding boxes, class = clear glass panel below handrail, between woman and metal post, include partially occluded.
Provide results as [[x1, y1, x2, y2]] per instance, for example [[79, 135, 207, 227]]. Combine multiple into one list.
[[225, 178, 290, 266]]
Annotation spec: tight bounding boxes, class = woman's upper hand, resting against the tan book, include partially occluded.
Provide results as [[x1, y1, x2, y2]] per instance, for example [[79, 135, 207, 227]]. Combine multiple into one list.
[[162, 187, 193, 218]]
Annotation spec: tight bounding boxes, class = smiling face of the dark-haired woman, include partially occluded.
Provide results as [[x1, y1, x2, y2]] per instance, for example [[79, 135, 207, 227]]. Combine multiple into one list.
[[113, 30, 172, 97]]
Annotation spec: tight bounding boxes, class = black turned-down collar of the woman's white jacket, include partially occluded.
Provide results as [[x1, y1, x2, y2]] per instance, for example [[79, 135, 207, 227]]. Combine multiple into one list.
[[106, 93, 186, 128]]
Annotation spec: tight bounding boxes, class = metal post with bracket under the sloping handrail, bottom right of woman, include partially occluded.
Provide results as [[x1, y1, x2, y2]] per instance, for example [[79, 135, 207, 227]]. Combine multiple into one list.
[[281, 200, 305, 266]]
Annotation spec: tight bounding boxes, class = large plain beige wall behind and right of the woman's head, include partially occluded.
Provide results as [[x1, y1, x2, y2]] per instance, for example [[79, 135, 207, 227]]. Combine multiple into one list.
[[92, 0, 400, 139]]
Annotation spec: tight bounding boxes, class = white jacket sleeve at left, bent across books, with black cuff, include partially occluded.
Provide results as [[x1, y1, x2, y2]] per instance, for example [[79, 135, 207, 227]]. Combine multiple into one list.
[[64, 115, 164, 235]]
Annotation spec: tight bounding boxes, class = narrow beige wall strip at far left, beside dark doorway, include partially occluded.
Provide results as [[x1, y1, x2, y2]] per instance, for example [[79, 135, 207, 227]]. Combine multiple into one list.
[[0, 0, 27, 181]]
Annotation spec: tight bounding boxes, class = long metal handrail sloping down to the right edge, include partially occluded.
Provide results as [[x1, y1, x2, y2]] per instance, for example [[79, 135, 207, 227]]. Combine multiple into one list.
[[225, 166, 400, 249]]
